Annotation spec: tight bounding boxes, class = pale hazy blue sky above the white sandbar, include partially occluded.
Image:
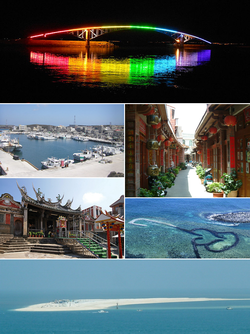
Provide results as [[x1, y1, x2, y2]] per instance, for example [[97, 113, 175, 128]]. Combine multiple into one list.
[[0, 260, 250, 301]]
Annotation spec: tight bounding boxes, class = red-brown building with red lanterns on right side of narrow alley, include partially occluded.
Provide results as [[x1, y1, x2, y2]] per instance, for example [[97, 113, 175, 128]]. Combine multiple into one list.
[[195, 104, 250, 197]]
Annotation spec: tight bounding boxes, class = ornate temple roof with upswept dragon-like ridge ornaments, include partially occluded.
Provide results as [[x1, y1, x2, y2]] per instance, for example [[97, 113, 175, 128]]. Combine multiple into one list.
[[17, 183, 82, 214]]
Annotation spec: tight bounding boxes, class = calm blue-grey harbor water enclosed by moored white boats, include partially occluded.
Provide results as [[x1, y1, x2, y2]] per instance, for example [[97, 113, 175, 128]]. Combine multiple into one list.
[[2, 134, 110, 169]]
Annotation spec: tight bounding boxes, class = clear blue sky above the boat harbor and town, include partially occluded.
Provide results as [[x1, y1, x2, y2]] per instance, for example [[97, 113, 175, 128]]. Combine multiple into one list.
[[0, 103, 124, 126]]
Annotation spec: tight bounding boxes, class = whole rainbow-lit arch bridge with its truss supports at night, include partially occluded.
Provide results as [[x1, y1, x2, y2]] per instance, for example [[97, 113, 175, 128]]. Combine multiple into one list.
[[29, 25, 211, 44]]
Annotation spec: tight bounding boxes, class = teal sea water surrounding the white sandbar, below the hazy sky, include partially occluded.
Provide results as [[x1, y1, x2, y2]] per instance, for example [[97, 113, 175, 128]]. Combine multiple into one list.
[[0, 293, 250, 334]]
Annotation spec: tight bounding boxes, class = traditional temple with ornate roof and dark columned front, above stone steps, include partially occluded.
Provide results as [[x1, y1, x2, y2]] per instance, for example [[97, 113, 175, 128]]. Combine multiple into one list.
[[0, 185, 83, 237]]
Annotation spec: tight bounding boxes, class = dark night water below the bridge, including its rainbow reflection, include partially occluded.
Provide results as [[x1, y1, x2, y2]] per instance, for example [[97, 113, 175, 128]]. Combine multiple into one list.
[[0, 46, 250, 103]]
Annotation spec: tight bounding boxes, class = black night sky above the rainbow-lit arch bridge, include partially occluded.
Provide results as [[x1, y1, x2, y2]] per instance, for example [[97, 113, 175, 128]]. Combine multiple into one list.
[[0, 0, 250, 42]]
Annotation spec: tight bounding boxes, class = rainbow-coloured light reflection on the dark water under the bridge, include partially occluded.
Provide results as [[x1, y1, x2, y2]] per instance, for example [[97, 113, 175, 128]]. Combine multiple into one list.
[[30, 49, 211, 87]]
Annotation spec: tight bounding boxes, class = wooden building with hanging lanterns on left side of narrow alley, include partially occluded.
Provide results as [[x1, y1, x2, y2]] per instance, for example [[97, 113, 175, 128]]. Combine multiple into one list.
[[125, 104, 185, 197]]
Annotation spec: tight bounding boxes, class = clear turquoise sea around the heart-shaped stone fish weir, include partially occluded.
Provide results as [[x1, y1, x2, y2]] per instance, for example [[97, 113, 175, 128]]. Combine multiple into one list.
[[125, 198, 250, 258]]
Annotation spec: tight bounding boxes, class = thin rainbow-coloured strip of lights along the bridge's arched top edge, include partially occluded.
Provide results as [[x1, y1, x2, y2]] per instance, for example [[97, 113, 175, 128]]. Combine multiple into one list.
[[29, 25, 212, 44]]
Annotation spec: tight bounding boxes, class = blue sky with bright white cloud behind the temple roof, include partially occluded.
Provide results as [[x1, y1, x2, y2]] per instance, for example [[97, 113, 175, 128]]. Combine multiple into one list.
[[0, 178, 124, 211]]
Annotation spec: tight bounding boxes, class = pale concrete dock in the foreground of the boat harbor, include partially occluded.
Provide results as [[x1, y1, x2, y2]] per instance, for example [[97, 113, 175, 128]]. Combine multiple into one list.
[[0, 150, 124, 178]]
